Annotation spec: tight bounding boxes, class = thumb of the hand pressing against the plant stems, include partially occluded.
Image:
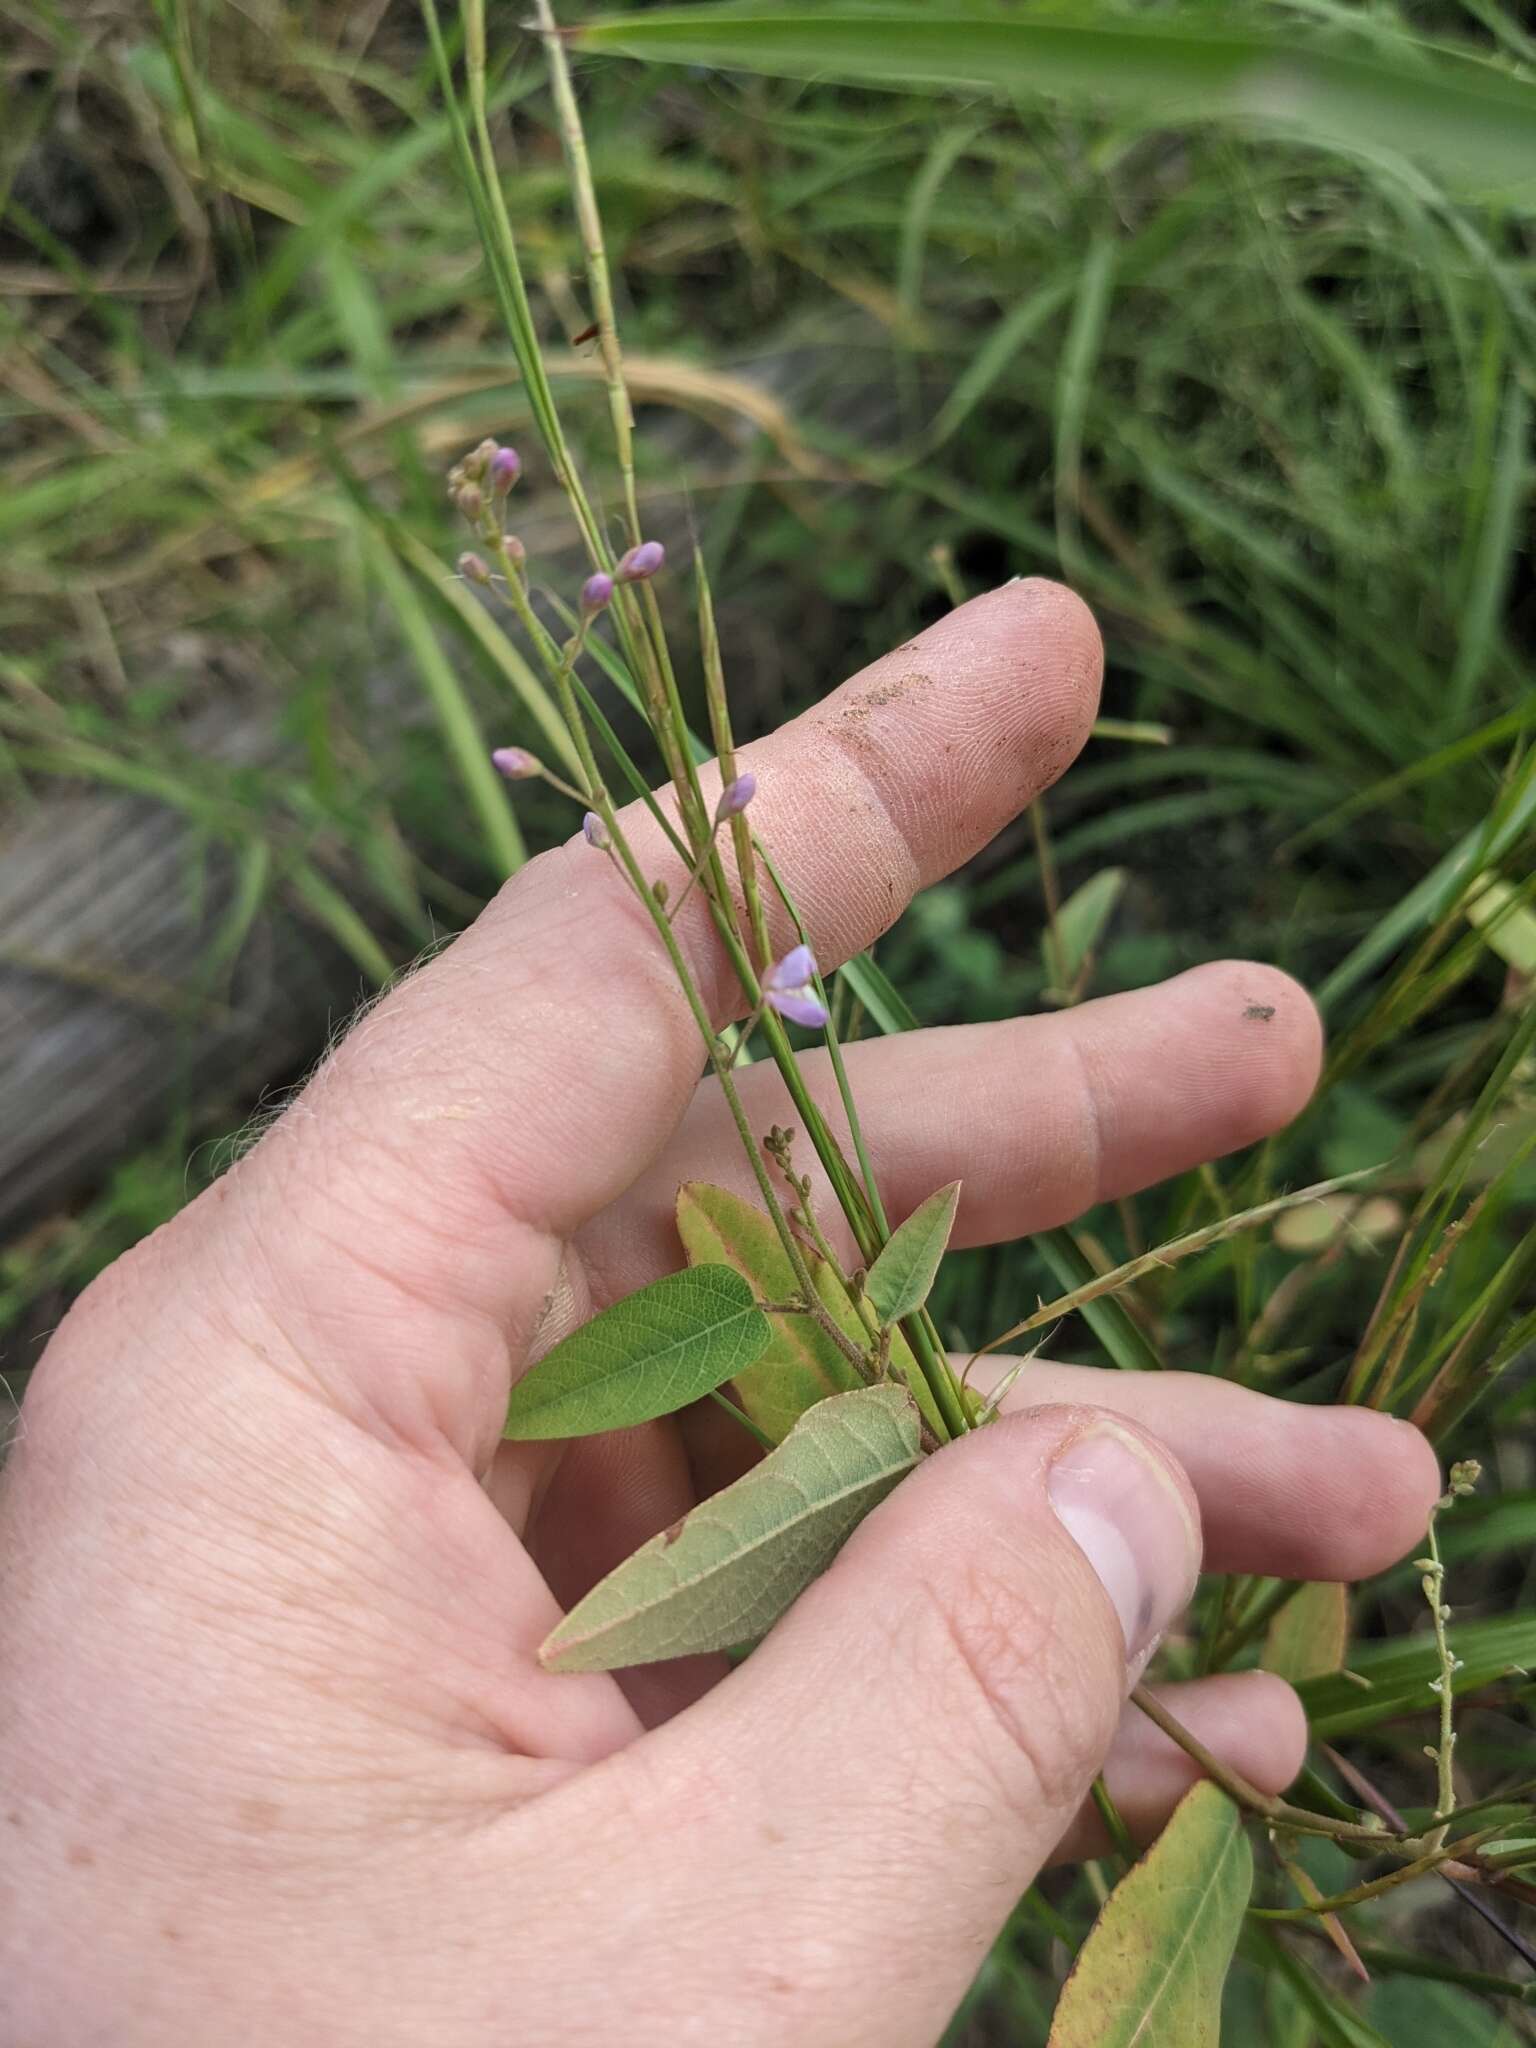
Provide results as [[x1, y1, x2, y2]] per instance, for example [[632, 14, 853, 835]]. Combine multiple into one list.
[[610, 1407, 1200, 2048]]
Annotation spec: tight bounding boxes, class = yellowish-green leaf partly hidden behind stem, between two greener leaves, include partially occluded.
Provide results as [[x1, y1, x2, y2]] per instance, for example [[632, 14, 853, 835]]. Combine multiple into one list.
[[678, 1180, 868, 1444]]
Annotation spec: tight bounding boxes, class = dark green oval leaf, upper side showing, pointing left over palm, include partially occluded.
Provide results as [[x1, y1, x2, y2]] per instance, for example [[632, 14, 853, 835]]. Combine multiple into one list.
[[504, 1266, 772, 1438]]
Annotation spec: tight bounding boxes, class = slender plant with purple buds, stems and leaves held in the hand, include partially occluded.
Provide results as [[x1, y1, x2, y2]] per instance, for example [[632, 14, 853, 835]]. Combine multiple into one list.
[[409, 0, 1536, 2042]]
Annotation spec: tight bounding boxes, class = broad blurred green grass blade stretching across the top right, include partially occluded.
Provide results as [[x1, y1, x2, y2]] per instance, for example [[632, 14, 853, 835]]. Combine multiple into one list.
[[573, 6, 1536, 203]]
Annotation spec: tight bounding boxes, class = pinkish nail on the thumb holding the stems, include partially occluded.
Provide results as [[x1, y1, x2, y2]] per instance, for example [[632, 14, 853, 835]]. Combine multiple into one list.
[[1047, 1423, 1200, 1659]]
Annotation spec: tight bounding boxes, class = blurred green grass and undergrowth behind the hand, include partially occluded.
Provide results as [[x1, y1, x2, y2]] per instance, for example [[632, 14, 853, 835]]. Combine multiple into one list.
[[0, 0, 1536, 2048]]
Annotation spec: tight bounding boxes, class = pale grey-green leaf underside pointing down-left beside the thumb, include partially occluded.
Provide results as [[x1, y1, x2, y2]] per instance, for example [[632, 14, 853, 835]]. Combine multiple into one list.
[[539, 1386, 920, 1671]]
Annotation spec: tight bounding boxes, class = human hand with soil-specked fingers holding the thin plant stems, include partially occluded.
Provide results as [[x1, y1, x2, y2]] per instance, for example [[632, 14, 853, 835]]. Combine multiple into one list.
[[0, 582, 1438, 2048]]
